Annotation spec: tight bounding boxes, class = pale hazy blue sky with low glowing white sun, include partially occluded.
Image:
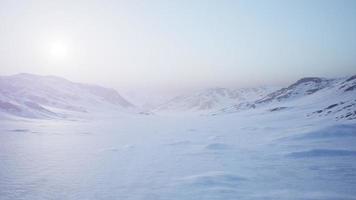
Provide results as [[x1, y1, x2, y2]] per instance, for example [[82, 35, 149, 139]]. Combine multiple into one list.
[[0, 0, 356, 88]]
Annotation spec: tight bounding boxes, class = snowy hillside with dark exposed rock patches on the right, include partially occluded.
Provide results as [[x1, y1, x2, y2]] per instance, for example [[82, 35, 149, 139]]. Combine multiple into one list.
[[219, 75, 356, 120]]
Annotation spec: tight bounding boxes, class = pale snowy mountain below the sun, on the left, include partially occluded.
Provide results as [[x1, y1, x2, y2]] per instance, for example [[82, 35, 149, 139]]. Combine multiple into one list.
[[0, 74, 134, 118]]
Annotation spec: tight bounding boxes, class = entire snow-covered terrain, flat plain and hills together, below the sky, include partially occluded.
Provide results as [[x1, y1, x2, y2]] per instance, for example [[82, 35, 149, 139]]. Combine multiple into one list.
[[0, 74, 356, 200]]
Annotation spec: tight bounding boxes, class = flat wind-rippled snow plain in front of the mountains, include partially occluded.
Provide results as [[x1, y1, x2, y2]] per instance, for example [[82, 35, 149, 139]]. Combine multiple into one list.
[[0, 110, 356, 200]]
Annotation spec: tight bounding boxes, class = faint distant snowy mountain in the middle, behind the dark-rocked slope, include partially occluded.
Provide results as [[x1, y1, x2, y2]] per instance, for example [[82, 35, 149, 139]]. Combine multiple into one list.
[[155, 87, 276, 112]]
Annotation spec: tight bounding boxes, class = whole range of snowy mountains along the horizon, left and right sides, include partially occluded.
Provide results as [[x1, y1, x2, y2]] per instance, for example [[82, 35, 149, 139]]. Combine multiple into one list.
[[0, 74, 356, 120]]
